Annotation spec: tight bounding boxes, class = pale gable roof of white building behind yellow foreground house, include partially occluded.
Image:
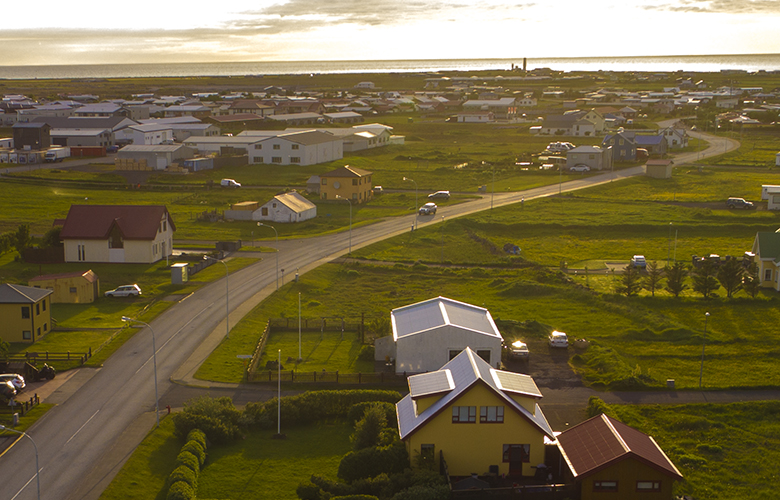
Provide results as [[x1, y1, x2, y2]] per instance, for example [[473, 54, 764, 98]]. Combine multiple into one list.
[[390, 297, 502, 340]]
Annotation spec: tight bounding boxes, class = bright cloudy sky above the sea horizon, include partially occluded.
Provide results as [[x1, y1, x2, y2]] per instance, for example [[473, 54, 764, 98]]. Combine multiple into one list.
[[0, 0, 780, 66]]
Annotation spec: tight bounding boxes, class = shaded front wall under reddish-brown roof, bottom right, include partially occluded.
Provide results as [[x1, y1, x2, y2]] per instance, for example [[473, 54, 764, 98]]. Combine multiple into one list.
[[582, 458, 673, 500]]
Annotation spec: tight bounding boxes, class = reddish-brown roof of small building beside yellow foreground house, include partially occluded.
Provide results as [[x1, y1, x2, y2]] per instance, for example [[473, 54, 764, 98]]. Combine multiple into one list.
[[558, 414, 682, 479]]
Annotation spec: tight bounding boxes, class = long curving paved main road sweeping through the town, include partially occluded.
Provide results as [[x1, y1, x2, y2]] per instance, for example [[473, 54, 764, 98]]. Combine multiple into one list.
[[0, 130, 744, 500]]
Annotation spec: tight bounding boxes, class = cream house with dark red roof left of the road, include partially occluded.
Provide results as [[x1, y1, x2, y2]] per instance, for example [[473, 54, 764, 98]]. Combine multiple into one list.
[[60, 204, 176, 264]]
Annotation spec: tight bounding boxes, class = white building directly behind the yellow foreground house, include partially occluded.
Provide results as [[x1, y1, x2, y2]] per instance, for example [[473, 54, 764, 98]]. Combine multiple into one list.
[[377, 297, 503, 373]]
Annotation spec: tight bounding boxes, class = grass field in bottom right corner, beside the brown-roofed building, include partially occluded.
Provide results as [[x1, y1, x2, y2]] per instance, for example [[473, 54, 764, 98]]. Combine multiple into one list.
[[596, 401, 780, 500]]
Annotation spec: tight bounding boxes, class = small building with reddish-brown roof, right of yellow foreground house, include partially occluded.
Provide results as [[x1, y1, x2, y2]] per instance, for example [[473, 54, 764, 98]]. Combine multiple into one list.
[[557, 414, 683, 500]]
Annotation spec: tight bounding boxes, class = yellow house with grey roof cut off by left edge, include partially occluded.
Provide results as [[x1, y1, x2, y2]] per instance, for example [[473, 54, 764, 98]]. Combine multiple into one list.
[[0, 283, 52, 344]]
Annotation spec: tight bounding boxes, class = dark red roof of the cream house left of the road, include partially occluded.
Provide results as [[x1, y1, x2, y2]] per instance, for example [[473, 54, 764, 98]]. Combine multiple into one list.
[[60, 205, 176, 240]]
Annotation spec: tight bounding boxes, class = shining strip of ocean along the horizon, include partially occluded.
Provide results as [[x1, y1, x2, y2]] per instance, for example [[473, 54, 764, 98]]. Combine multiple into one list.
[[0, 54, 780, 79]]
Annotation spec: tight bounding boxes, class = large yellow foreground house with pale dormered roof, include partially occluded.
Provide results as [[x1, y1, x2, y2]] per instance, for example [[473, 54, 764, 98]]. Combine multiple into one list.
[[396, 347, 553, 477]]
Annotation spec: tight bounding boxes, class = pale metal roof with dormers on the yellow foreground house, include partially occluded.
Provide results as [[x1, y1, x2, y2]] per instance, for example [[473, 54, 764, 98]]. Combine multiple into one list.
[[395, 347, 553, 440]]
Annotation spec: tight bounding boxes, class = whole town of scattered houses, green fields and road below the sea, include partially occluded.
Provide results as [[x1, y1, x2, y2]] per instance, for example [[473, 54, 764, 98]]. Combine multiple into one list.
[[0, 66, 780, 500]]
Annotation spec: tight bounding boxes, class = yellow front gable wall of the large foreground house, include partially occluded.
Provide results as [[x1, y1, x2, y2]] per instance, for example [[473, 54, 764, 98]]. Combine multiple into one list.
[[406, 384, 544, 476]]
